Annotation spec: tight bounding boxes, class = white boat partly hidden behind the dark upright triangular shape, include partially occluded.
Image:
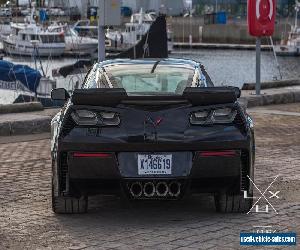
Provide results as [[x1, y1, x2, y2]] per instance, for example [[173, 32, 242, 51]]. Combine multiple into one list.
[[106, 9, 173, 53]]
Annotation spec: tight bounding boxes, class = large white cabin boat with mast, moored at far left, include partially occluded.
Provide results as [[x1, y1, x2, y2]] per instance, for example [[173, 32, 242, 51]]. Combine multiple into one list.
[[3, 4, 65, 57]]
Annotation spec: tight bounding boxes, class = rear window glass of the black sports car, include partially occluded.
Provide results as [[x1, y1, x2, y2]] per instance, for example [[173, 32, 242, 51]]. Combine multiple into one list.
[[104, 62, 194, 95]]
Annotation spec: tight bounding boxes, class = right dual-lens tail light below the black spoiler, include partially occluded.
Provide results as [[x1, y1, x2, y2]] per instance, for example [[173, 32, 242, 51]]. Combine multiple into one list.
[[190, 107, 237, 125]]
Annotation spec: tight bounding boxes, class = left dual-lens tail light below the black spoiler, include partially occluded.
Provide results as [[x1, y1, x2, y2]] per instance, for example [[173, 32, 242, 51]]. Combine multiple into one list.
[[71, 109, 121, 126]]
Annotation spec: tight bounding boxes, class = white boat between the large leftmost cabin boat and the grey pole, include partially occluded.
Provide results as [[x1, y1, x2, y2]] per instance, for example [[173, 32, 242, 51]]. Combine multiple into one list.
[[48, 25, 98, 55]]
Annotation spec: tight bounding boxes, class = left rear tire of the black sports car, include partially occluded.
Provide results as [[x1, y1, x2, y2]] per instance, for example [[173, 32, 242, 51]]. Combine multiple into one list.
[[52, 182, 88, 214]]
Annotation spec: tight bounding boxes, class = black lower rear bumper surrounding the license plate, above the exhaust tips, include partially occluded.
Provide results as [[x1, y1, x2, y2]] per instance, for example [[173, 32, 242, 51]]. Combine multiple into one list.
[[58, 139, 251, 195]]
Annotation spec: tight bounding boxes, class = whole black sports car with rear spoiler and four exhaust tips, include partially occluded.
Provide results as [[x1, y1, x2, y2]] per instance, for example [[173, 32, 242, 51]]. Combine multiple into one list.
[[51, 59, 255, 213]]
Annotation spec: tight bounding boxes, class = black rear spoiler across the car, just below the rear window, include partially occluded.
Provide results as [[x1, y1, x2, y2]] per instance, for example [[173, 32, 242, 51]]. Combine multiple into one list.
[[72, 87, 241, 107]]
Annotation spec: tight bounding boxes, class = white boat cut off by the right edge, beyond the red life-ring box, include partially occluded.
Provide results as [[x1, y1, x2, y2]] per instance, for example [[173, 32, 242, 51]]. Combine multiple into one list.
[[274, 1, 300, 56]]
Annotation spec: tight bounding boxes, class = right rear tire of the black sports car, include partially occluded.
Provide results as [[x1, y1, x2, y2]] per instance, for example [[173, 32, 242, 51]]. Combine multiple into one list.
[[215, 193, 253, 213]]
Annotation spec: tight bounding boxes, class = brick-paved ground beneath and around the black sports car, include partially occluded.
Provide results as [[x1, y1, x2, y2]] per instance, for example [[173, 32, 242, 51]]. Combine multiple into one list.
[[0, 104, 300, 249]]
